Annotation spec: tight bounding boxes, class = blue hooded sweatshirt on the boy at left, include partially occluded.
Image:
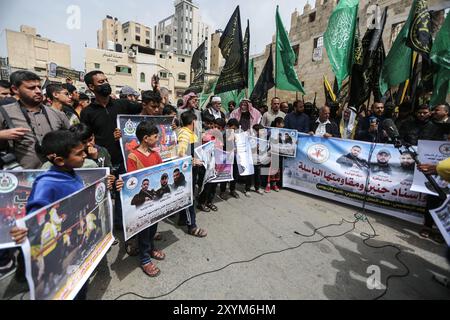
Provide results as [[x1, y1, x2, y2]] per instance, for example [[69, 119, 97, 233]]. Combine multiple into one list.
[[26, 166, 84, 214]]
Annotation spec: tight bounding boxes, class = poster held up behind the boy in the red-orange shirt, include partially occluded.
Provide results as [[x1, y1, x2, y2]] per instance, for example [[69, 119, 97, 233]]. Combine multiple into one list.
[[117, 115, 177, 170]]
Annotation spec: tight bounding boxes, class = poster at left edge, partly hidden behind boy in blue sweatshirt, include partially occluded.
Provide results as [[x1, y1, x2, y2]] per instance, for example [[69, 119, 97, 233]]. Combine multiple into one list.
[[0, 168, 109, 249]]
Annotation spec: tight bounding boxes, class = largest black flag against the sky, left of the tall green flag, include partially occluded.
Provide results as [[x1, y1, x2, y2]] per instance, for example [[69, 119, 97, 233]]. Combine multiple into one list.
[[214, 6, 248, 94]]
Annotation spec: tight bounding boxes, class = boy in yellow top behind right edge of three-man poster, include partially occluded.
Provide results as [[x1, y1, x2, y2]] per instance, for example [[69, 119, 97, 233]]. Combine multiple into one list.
[[178, 112, 207, 238]]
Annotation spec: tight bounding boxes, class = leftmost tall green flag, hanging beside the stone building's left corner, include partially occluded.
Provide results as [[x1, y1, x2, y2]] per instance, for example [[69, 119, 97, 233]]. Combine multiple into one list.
[[275, 6, 305, 94]]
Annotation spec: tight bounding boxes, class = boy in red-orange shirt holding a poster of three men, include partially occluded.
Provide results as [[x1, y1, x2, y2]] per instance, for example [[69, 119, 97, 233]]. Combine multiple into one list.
[[127, 121, 166, 278]]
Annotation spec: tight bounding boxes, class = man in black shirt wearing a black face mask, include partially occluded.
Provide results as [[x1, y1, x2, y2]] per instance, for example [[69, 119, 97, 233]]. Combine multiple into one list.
[[80, 70, 142, 228]]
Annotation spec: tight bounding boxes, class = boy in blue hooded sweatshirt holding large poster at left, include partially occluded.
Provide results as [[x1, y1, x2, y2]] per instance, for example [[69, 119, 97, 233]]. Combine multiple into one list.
[[11, 130, 123, 300]]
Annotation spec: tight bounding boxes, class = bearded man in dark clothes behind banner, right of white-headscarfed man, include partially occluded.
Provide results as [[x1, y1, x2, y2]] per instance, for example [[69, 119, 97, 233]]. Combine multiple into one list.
[[356, 102, 388, 142]]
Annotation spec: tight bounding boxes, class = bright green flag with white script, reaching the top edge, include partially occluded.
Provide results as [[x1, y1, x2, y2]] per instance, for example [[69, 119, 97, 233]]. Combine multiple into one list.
[[323, 0, 358, 89]]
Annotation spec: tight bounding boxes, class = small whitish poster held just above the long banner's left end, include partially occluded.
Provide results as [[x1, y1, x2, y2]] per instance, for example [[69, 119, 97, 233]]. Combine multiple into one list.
[[266, 128, 298, 158]]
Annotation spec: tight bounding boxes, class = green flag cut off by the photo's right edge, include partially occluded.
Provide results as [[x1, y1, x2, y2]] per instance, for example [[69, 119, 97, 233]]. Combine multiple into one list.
[[430, 14, 450, 106]]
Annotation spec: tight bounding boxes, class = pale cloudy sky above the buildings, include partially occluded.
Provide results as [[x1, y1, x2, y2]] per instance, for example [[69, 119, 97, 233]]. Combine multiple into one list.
[[0, 0, 314, 70]]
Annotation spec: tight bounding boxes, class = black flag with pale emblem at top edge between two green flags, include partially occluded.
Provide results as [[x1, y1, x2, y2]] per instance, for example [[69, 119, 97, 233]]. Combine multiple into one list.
[[406, 0, 433, 55]]
